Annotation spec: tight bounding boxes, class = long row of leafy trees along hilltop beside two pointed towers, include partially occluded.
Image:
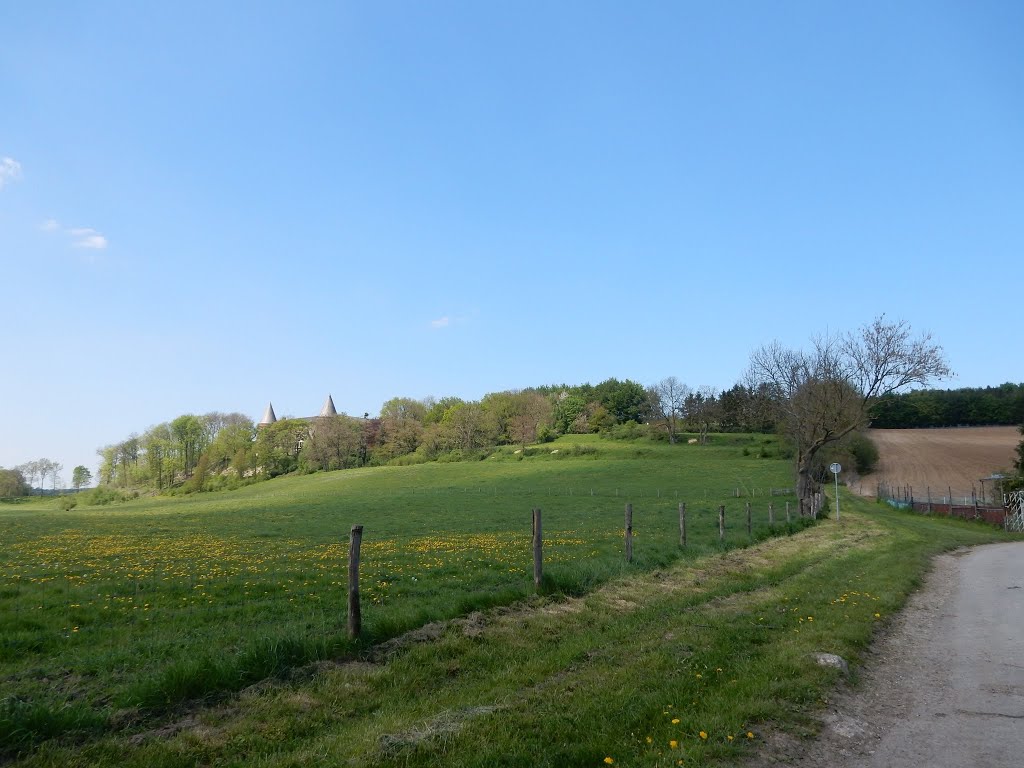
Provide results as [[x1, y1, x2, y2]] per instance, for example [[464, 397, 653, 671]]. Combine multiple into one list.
[[86, 377, 775, 497]]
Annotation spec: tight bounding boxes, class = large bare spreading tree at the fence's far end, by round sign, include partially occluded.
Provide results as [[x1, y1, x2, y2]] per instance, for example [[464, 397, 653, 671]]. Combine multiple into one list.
[[748, 315, 950, 500]]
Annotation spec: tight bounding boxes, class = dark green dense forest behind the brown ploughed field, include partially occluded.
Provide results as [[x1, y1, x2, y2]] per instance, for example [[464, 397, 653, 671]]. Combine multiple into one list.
[[871, 384, 1024, 429]]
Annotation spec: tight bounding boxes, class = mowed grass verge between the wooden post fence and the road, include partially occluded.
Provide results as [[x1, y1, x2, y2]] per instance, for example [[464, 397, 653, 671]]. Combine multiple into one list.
[[12, 497, 1007, 767]]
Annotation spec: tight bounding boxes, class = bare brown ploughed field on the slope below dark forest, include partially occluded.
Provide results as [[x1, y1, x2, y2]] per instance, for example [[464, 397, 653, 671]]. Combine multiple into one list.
[[854, 427, 1021, 497]]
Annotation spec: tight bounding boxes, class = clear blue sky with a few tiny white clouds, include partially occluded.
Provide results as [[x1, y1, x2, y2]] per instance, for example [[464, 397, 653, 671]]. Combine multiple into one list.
[[0, 1, 1024, 479]]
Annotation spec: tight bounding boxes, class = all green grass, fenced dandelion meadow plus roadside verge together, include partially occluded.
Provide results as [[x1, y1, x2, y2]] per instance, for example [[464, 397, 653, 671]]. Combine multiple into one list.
[[0, 435, 1006, 766]]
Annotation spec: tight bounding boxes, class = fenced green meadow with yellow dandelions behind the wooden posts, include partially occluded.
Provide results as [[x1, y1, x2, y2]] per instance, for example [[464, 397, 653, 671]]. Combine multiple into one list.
[[0, 436, 791, 755]]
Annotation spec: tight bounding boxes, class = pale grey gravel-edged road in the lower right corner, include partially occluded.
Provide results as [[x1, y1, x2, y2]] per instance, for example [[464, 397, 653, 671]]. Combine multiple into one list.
[[749, 542, 1024, 768]]
